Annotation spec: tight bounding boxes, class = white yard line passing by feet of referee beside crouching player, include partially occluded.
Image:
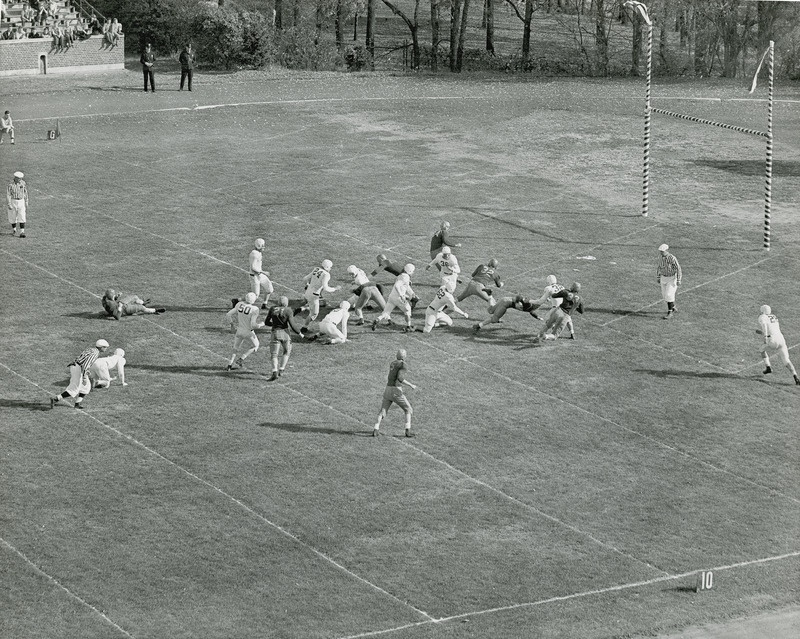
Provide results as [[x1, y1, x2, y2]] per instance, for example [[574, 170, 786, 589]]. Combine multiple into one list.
[[0, 364, 432, 624]]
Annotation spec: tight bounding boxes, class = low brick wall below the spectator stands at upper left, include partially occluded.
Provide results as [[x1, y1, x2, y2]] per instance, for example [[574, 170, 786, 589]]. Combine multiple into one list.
[[0, 35, 125, 76]]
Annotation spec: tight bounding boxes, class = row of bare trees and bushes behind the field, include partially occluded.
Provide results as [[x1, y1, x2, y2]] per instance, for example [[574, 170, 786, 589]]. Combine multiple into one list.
[[90, 0, 800, 78]]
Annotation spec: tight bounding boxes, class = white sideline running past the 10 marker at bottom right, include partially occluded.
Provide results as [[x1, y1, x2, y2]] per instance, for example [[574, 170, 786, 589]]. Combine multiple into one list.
[[341, 551, 800, 639]]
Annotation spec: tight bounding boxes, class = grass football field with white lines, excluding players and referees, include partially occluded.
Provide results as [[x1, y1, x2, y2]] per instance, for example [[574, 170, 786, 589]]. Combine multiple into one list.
[[0, 72, 800, 639]]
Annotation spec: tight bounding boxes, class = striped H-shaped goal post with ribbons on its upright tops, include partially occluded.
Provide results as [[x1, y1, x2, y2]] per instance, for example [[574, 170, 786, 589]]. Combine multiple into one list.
[[624, 0, 775, 251]]
